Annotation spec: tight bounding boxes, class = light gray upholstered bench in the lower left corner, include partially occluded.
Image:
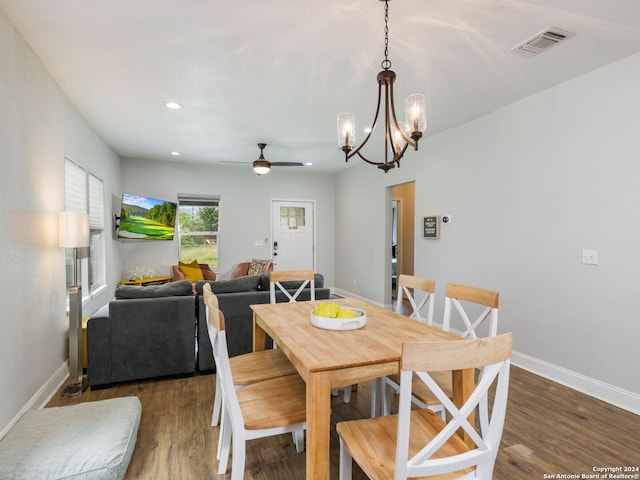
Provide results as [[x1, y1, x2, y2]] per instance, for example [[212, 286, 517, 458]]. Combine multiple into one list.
[[0, 397, 142, 480]]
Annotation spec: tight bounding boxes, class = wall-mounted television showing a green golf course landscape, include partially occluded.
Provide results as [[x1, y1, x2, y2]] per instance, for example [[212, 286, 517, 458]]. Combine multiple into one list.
[[118, 193, 178, 240]]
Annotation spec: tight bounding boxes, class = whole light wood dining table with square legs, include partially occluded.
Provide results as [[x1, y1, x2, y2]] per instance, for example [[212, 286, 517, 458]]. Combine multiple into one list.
[[251, 298, 475, 480]]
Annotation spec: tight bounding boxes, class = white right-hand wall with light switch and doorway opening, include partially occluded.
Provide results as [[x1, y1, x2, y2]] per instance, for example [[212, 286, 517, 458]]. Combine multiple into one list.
[[335, 55, 640, 413]]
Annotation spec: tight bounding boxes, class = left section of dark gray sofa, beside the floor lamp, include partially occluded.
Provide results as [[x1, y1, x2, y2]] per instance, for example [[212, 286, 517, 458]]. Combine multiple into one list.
[[87, 280, 196, 387]]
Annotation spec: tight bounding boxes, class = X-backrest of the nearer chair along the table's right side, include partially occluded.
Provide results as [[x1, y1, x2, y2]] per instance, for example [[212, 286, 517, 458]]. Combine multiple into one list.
[[442, 283, 500, 338]]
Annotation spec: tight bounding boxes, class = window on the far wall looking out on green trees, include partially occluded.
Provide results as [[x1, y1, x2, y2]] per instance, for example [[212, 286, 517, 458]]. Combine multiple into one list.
[[178, 195, 220, 269]]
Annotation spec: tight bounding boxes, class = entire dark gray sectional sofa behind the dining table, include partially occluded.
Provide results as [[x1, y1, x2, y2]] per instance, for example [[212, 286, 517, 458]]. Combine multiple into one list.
[[87, 274, 330, 388]]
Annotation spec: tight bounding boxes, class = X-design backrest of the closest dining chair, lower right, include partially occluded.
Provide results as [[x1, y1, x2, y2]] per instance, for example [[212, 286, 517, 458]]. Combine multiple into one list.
[[395, 333, 513, 479]]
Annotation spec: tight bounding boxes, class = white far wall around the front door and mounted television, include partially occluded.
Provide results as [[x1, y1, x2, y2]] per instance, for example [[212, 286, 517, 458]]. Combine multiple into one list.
[[115, 159, 334, 286]]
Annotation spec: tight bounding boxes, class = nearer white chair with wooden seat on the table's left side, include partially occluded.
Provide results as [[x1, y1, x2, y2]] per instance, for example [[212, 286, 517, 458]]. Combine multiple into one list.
[[207, 298, 306, 480]]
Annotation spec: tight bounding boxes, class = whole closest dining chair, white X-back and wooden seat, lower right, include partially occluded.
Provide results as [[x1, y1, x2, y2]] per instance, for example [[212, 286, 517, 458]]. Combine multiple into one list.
[[336, 333, 513, 480]]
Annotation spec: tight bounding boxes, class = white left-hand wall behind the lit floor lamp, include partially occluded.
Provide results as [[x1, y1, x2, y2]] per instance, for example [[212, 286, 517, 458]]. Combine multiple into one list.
[[0, 9, 120, 437]]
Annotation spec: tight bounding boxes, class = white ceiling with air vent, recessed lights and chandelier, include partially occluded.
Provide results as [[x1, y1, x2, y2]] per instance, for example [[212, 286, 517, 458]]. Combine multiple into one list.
[[0, 0, 640, 174]]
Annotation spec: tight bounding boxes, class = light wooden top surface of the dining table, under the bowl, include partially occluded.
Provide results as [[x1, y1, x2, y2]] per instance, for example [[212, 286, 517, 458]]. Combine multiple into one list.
[[251, 298, 460, 376]]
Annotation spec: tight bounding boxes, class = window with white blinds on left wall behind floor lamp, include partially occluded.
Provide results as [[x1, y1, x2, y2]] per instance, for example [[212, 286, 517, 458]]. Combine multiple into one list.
[[64, 157, 105, 293]]
